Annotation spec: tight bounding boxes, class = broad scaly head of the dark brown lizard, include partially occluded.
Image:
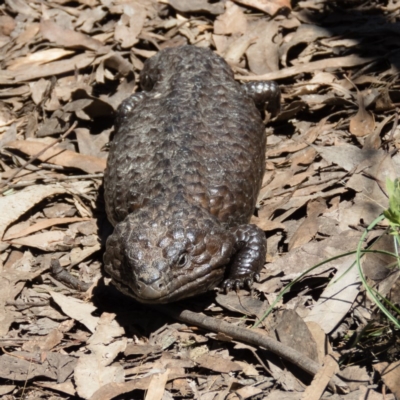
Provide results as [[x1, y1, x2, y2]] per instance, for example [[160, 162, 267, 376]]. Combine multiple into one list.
[[104, 206, 234, 303]]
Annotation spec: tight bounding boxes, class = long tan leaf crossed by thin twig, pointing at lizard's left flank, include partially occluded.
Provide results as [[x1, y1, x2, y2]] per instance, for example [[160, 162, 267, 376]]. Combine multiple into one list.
[[7, 140, 106, 174]]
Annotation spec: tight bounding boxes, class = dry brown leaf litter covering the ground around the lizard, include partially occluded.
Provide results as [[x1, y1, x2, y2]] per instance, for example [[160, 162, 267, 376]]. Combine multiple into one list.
[[0, 0, 400, 400]]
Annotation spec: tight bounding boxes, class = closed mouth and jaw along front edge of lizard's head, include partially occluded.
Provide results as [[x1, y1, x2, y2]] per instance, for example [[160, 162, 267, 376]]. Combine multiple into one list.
[[112, 268, 224, 304]]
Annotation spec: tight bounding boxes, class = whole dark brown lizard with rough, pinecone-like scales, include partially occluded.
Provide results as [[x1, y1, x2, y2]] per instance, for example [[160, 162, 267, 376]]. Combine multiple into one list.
[[104, 46, 279, 303]]
